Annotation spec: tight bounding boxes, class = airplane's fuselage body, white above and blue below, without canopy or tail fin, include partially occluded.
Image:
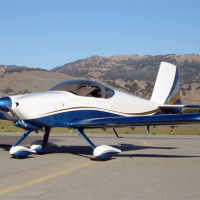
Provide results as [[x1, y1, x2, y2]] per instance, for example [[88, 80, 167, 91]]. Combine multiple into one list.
[[3, 90, 158, 127]]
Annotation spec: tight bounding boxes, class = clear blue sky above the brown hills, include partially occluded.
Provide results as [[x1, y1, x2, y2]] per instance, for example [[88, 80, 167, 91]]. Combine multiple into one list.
[[0, 0, 200, 69]]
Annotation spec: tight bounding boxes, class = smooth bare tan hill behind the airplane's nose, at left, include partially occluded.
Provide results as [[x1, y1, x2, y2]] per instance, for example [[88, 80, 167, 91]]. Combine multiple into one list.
[[0, 70, 73, 96]]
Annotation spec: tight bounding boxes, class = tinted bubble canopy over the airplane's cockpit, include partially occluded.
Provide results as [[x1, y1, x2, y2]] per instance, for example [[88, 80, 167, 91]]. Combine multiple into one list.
[[49, 79, 115, 99]]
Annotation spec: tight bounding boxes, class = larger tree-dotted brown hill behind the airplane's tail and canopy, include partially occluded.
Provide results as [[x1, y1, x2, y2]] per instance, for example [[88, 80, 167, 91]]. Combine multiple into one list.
[[52, 54, 200, 104]]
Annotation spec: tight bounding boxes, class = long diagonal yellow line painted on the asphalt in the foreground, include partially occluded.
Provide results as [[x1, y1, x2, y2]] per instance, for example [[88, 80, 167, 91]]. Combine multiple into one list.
[[0, 161, 95, 195]]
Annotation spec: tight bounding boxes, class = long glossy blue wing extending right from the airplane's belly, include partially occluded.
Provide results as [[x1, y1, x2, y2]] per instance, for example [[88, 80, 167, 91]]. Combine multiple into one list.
[[70, 113, 200, 128]]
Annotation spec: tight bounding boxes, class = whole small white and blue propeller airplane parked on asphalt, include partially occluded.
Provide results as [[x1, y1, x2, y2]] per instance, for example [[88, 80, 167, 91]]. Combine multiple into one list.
[[0, 62, 200, 160]]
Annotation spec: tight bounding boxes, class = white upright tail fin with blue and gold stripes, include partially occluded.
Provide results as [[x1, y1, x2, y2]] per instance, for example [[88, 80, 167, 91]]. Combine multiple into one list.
[[151, 62, 181, 105]]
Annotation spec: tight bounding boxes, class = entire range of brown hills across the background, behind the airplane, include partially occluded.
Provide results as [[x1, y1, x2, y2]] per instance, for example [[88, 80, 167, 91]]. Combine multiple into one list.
[[0, 54, 200, 104]]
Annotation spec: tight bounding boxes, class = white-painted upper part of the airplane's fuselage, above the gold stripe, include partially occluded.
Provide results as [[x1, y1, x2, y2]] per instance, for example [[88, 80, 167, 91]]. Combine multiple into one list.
[[7, 90, 158, 120]]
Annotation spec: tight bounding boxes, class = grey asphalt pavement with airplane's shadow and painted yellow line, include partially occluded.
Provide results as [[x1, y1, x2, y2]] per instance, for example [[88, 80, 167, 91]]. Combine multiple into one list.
[[0, 133, 200, 200]]
